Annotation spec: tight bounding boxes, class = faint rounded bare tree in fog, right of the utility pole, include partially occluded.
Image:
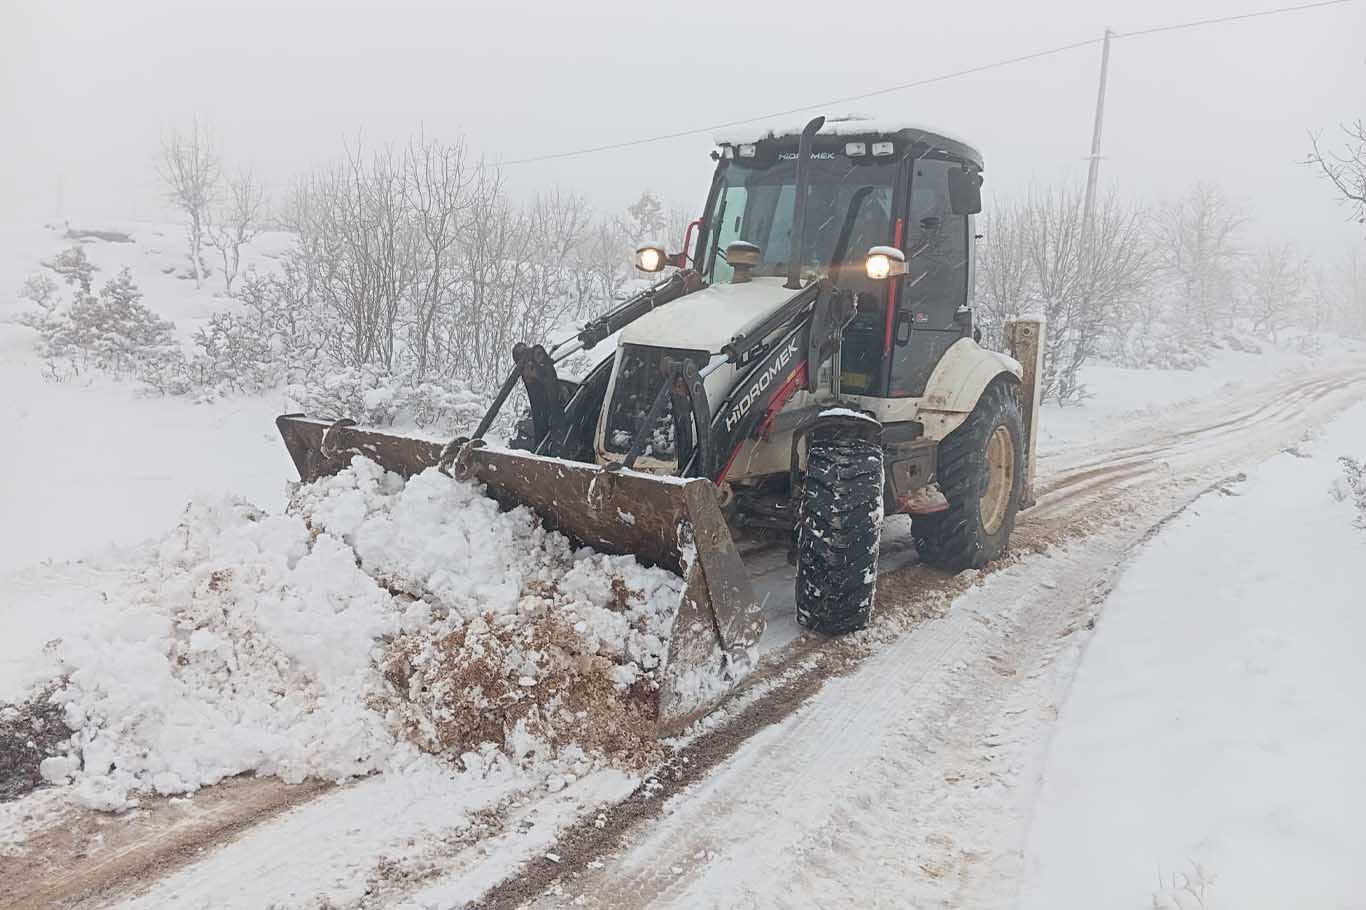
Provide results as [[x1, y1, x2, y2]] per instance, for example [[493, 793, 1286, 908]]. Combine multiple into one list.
[[1153, 183, 1247, 342]]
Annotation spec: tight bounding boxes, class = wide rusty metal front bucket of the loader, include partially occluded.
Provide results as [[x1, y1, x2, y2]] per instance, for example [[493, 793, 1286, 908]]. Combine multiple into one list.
[[276, 414, 764, 735]]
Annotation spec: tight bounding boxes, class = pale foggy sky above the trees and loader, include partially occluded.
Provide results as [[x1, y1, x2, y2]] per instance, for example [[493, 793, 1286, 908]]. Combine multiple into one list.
[[0, 0, 1366, 258]]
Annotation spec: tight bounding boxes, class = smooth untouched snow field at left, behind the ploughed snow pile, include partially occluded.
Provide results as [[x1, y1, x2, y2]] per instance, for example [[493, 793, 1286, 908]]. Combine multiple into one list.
[[0, 324, 294, 573]]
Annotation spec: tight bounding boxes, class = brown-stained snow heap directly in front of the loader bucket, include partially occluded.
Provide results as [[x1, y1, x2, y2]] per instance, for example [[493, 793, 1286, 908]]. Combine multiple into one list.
[[291, 462, 682, 764]]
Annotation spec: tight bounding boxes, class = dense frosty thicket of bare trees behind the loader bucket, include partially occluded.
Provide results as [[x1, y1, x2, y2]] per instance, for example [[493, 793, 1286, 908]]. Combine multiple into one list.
[[247, 130, 630, 400]]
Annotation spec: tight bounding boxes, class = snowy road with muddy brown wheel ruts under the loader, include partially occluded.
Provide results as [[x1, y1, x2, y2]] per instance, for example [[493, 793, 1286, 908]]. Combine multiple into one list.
[[0, 332, 1366, 907]]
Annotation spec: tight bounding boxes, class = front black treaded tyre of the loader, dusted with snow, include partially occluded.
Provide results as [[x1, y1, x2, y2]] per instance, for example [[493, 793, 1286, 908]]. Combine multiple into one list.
[[796, 435, 882, 635]]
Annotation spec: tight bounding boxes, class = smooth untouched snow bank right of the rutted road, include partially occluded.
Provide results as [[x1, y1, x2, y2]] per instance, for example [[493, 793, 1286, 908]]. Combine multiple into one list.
[[1020, 406, 1366, 909]]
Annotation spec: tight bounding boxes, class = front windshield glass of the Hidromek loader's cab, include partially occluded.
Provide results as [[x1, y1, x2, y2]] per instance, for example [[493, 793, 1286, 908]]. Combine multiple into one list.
[[703, 150, 897, 283]]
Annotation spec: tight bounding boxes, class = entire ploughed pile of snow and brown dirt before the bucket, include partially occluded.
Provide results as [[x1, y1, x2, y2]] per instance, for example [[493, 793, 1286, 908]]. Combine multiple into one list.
[[14, 459, 682, 809]]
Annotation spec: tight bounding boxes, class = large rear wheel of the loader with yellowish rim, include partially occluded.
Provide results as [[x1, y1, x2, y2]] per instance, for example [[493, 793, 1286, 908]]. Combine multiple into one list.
[[911, 381, 1025, 573]]
